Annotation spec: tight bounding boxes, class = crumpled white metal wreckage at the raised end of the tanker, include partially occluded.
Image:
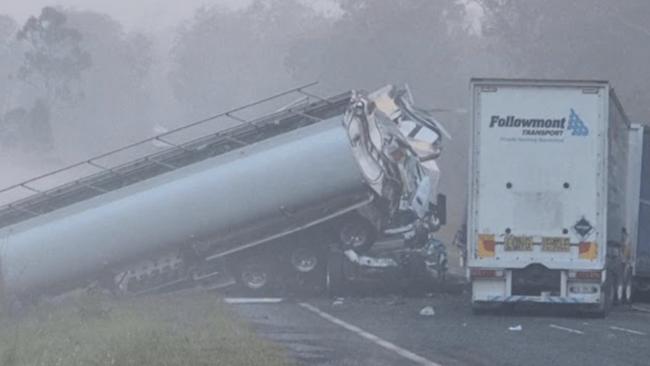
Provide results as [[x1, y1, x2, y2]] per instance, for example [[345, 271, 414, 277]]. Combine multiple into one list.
[[344, 85, 442, 225]]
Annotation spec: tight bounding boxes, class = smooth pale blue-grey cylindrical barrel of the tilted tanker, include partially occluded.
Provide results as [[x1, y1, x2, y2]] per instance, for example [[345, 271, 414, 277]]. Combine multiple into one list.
[[0, 118, 367, 295]]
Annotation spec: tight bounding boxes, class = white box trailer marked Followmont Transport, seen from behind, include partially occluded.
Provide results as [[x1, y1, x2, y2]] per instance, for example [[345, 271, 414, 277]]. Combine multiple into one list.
[[467, 79, 634, 314]]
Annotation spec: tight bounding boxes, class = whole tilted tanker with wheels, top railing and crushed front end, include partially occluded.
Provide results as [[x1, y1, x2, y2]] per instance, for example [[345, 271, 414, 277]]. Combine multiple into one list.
[[0, 86, 448, 300]]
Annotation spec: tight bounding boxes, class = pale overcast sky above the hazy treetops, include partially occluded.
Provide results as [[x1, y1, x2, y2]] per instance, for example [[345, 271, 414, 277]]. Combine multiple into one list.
[[0, 0, 338, 30]]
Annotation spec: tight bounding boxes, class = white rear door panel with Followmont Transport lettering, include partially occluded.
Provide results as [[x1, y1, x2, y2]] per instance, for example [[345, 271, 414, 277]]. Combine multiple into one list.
[[468, 80, 609, 269]]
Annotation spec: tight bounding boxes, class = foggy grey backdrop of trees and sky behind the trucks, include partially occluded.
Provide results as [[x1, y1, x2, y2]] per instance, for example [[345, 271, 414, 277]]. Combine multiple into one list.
[[0, 0, 650, 242]]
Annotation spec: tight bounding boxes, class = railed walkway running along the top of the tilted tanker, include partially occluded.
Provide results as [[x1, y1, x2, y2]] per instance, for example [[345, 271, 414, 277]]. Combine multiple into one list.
[[0, 82, 350, 228]]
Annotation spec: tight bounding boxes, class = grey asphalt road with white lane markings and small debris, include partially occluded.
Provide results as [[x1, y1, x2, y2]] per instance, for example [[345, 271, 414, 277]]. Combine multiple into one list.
[[230, 294, 650, 366]]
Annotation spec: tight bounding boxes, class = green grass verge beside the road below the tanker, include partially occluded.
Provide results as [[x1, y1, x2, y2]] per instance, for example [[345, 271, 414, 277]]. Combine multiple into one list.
[[0, 292, 289, 366]]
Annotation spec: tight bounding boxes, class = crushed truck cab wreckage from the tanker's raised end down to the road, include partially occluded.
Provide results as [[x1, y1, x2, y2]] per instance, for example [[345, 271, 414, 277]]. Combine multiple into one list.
[[326, 85, 450, 296]]
